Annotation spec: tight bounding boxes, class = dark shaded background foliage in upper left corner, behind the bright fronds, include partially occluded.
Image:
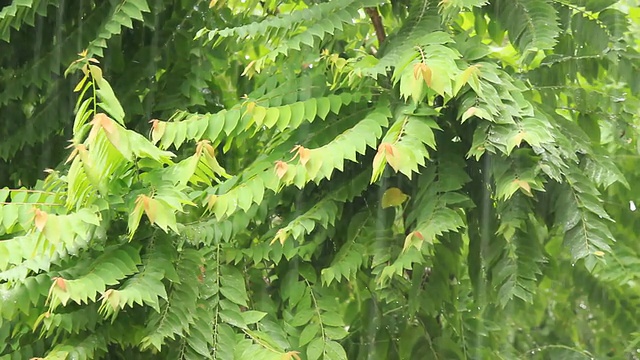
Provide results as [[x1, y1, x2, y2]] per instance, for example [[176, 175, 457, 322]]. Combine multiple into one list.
[[0, 0, 241, 187]]
